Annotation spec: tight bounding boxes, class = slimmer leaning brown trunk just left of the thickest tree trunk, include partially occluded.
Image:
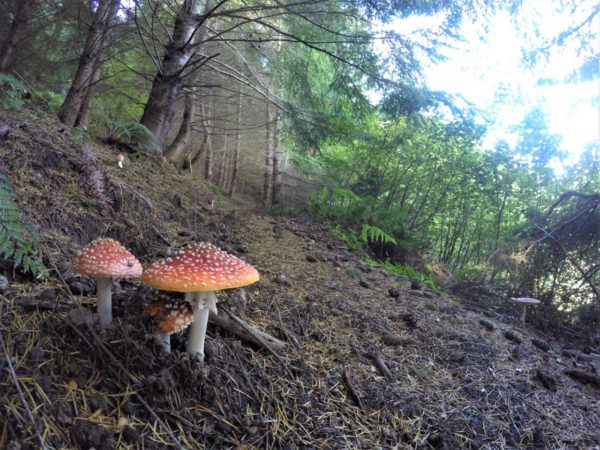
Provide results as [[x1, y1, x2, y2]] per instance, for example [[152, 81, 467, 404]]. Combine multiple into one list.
[[58, 0, 120, 127]]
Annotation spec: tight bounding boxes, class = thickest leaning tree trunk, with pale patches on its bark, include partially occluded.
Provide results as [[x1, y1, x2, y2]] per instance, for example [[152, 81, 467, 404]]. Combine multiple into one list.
[[140, 0, 211, 147]]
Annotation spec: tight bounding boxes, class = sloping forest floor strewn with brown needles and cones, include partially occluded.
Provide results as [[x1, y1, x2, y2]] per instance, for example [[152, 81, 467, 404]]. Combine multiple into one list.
[[0, 110, 600, 450]]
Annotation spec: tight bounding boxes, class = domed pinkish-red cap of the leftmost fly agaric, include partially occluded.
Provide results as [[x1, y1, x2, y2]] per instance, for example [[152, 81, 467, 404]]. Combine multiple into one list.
[[73, 238, 142, 278]]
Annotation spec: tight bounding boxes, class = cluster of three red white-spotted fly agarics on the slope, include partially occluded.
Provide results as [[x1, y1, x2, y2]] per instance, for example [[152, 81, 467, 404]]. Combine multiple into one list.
[[73, 239, 259, 360]]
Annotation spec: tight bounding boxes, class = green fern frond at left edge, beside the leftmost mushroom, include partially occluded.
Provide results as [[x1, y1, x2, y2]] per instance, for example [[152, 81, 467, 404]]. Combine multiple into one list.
[[0, 172, 47, 276]]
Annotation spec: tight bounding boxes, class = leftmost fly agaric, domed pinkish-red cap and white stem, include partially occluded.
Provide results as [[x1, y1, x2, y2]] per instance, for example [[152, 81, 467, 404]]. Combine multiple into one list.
[[73, 239, 142, 327]]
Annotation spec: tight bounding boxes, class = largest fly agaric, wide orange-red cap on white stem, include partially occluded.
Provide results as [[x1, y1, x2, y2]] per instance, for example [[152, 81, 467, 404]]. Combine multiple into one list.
[[142, 242, 259, 360]]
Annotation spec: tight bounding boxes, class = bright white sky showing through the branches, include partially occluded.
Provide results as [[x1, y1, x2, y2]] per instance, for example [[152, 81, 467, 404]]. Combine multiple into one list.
[[389, 0, 600, 164]]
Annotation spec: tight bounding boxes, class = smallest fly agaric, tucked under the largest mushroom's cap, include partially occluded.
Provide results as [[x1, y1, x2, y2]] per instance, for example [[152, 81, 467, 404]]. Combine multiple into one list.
[[144, 297, 194, 353]]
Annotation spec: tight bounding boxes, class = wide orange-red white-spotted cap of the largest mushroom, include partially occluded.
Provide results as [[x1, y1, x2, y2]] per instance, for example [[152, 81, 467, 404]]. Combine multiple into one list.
[[142, 242, 259, 292]]
